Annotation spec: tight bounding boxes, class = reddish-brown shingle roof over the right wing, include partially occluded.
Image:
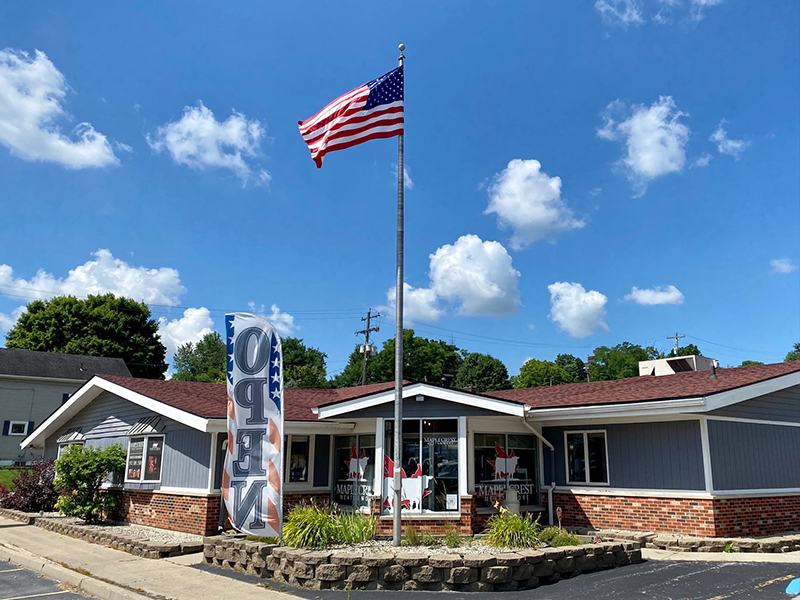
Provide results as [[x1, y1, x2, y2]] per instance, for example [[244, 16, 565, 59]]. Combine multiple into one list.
[[484, 362, 800, 409]]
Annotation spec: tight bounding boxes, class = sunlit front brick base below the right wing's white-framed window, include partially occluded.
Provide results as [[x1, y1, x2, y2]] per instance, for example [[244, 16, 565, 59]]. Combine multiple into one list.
[[553, 493, 718, 536]]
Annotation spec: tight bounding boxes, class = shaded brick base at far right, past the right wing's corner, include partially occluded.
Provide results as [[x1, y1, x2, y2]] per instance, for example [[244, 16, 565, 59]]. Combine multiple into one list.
[[714, 496, 800, 537]]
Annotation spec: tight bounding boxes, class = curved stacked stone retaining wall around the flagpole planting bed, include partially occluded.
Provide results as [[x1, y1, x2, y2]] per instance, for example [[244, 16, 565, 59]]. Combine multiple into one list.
[[203, 535, 642, 592]]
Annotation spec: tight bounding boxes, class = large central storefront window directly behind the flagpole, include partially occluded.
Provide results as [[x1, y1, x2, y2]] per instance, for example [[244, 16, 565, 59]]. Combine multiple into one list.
[[383, 419, 460, 513]]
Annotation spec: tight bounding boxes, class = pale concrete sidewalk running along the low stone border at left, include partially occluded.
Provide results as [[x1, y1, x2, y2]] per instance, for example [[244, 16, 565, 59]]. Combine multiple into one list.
[[0, 517, 291, 600]]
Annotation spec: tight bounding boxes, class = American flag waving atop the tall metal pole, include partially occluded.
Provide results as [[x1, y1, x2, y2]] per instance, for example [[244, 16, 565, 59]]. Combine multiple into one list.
[[298, 67, 403, 168]]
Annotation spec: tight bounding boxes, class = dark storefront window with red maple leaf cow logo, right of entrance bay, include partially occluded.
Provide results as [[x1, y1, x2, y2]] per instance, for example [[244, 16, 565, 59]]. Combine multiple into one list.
[[474, 433, 539, 507]]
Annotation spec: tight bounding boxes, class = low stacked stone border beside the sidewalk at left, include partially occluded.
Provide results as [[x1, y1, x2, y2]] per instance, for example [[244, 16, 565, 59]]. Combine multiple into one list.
[[0, 509, 203, 558]]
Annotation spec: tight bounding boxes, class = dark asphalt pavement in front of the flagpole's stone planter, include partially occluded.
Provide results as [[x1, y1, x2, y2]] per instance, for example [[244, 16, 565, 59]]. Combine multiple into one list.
[[197, 561, 800, 600]]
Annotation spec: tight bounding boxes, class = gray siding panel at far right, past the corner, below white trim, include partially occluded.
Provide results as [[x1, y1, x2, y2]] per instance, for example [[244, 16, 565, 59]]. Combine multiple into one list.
[[708, 420, 800, 490]]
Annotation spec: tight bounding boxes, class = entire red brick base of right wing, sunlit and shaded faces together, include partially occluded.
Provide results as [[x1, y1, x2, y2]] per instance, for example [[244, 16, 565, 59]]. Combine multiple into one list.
[[543, 492, 800, 537]]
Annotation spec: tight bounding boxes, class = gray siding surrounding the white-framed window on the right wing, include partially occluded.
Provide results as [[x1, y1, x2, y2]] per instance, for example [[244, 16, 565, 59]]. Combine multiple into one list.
[[543, 421, 705, 490]]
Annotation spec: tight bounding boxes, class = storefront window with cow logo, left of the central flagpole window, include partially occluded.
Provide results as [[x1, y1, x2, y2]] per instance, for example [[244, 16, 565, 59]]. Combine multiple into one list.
[[333, 435, 375, 507]]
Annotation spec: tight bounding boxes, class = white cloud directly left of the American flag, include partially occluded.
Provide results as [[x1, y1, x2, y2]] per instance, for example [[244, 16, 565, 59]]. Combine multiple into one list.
[[147, 101, 272, 184]]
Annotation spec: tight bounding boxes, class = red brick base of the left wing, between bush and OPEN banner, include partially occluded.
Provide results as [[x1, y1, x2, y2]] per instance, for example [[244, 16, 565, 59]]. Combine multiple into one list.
[[110, 490, 220, 535]]
